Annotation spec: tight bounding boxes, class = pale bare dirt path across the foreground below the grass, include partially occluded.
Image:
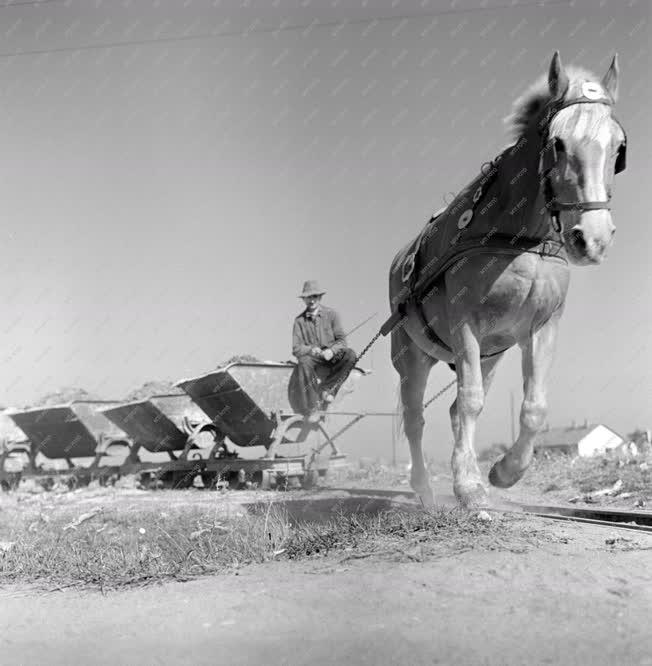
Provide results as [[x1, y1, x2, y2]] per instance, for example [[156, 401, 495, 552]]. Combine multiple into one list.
[[0, 519, 652, 666]]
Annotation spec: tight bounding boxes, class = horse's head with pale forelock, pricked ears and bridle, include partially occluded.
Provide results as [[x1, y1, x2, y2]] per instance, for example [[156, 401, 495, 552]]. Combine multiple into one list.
[[540, 53, 626, 265]]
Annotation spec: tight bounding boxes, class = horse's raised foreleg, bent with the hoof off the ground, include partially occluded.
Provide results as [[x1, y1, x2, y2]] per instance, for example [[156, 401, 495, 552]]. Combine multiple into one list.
[[489, 317, 559, 488]]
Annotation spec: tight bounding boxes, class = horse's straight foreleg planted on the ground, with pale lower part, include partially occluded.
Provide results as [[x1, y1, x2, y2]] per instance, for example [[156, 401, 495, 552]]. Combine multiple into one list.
[[451, 324, 488, 508]]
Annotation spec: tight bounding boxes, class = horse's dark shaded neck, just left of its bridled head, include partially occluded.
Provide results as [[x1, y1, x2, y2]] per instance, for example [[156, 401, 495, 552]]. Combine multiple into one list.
[[499, 129, 550, 238]]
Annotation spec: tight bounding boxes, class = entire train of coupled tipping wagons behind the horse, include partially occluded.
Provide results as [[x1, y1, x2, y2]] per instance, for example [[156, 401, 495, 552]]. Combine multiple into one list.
[[0, 361, 367, 489]]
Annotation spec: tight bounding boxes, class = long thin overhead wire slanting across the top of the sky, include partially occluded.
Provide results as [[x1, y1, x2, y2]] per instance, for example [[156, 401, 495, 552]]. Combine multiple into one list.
[[0, 0, 572, 58]]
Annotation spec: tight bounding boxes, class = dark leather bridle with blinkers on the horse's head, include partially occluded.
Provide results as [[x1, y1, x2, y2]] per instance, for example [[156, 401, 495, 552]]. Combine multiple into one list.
[[539, 96, 627, 233]]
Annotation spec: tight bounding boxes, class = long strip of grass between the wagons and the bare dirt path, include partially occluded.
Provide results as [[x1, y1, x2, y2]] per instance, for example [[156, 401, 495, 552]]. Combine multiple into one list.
[[0, 503, 544, 589]]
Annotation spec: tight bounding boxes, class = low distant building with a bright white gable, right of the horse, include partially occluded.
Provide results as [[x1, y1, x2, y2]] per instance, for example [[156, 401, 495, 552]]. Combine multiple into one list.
[[534, 423, 625, 458]]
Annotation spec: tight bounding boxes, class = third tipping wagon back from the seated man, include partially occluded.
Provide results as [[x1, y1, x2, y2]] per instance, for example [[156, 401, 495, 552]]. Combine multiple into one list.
[[9, 400, 132, 488]]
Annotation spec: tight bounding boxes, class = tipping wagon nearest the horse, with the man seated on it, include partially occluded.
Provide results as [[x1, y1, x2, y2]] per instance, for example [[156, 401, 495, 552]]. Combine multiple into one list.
[[176, 361, 367, 489]]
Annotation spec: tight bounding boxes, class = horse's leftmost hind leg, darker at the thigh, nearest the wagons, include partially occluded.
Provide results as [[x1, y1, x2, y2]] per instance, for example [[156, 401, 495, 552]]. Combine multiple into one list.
[[392, 329, 437, 506]]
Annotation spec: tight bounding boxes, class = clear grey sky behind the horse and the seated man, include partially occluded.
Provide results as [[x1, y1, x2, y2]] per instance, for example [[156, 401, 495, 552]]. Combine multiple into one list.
[[0, 0, 652, 459]]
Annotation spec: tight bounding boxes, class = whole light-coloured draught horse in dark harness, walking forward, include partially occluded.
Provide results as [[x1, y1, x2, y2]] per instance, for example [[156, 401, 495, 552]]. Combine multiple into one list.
[[386, 51, 627, 509]]
